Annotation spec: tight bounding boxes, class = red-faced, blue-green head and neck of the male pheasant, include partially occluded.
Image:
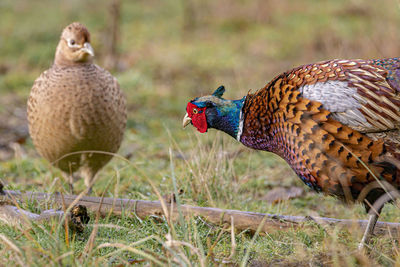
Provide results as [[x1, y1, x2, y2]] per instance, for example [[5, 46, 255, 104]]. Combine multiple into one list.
[[183, 86, 245, 138]]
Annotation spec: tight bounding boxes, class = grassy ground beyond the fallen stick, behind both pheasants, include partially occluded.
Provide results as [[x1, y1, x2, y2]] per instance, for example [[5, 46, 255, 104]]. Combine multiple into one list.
[[0, 0, 400, 266]]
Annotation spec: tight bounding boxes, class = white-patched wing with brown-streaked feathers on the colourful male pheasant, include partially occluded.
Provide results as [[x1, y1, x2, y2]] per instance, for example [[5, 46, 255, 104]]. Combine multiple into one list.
[[287, 58, 400, 133]]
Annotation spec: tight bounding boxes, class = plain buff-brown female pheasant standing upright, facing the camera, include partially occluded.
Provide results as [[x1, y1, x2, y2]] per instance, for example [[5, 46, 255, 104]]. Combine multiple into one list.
[[28, 22, 127, 194]]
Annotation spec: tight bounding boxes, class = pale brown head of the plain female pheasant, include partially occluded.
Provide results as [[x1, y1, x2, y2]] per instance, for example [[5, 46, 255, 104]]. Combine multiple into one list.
[[55, 22, 94, 65]]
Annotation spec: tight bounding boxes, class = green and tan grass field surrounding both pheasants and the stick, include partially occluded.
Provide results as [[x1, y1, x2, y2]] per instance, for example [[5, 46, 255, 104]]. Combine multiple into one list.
[[0, 0, 400, 266]]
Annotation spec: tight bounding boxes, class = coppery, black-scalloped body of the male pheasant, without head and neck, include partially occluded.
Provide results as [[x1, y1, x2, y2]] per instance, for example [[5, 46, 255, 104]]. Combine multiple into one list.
[[240, 60, 400, 200]]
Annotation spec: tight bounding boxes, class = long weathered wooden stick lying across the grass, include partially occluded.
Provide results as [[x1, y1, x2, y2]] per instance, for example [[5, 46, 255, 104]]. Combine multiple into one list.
[[0, 190, 400, 235]]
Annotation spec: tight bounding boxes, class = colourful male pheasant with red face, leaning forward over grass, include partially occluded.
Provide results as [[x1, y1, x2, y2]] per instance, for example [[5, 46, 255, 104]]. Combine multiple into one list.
[[183, 58, 400, 248]]
